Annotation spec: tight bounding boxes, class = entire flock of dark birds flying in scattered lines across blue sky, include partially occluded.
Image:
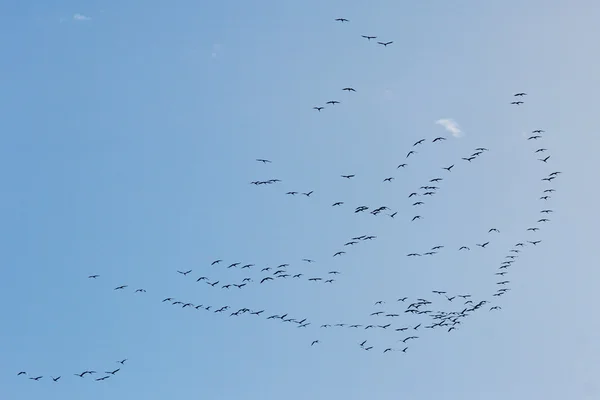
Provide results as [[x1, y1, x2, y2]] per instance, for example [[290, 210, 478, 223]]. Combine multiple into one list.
[[17, 18, 561, 382]]
